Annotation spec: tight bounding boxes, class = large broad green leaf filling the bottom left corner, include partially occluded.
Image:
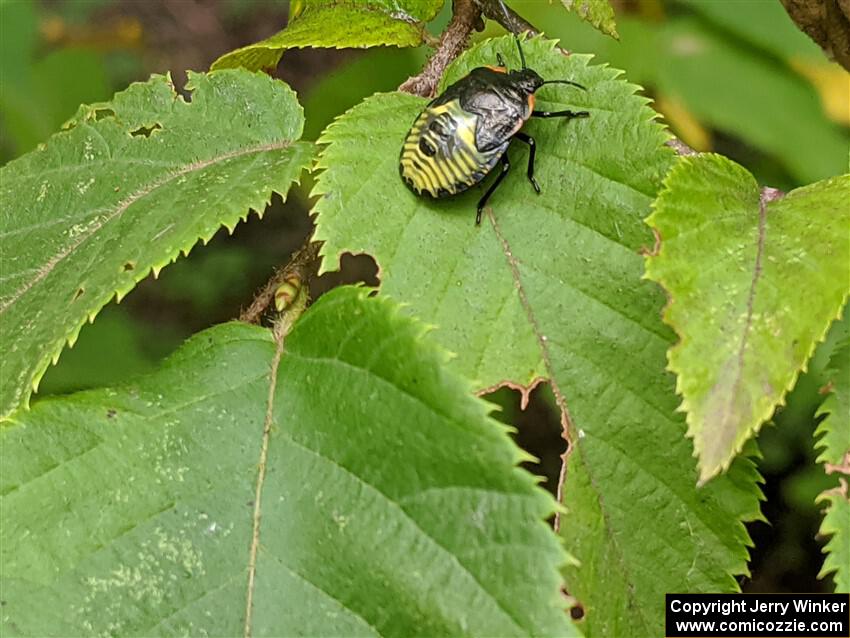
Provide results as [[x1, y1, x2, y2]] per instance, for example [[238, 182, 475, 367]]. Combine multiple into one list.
[[0, 288, 577, 636]]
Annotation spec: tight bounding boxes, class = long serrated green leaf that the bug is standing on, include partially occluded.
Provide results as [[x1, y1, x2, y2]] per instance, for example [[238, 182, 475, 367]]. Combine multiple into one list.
[[314, 38, 758, 636]]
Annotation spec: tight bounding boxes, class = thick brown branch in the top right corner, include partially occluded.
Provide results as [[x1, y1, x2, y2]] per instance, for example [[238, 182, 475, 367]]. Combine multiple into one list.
[[782, 0, 850, 71]]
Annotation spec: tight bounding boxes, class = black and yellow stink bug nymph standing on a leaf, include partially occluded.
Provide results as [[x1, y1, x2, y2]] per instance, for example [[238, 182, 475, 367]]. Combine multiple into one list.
[[399, 12, 590, 225]]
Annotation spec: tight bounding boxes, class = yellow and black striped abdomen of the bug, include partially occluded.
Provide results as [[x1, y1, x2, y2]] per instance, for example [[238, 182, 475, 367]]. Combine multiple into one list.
[[399, 100, 510, 197]]
